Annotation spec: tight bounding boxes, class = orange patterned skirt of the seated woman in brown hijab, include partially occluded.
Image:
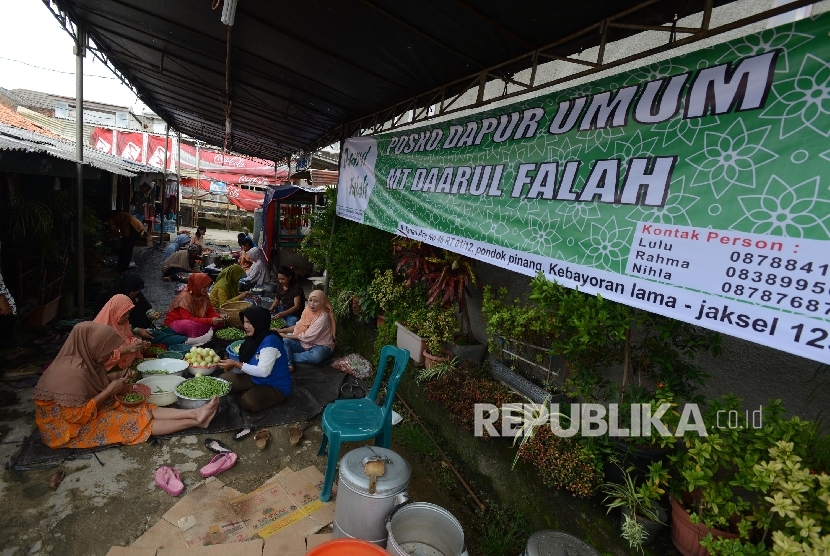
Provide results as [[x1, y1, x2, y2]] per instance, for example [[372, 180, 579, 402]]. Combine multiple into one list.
[[35, 399, 156, 448]]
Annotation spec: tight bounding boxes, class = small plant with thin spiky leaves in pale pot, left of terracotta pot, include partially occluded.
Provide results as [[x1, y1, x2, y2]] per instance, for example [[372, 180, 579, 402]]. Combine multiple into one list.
[[600, 462, 668, 552]]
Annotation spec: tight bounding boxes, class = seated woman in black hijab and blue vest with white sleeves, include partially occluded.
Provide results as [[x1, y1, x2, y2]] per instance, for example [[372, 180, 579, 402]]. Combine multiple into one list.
[[219, 307, 292, 412]]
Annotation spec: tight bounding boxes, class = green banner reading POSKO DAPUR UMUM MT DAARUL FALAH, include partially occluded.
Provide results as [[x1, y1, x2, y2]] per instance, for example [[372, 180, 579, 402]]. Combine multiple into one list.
[[337, 14, 830, 363]]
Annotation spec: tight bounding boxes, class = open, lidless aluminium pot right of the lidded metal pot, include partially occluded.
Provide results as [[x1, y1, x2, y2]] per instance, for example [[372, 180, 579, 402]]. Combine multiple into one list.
[[386, 504, 469, 556]]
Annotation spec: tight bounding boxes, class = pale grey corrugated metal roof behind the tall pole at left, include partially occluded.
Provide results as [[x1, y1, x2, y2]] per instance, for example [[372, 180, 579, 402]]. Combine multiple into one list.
[[0, 124, 161, 178]]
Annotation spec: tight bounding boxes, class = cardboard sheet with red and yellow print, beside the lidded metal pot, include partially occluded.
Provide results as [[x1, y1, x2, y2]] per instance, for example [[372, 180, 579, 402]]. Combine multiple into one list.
[[230, 466, 334, 538]]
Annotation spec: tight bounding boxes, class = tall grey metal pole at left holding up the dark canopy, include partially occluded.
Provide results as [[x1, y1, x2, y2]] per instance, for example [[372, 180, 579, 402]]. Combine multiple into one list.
[[75, 21, 86, 319]]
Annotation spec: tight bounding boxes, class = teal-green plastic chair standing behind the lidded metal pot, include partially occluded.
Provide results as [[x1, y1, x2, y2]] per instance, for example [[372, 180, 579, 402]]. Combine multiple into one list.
[[317, 346, 409, 502]]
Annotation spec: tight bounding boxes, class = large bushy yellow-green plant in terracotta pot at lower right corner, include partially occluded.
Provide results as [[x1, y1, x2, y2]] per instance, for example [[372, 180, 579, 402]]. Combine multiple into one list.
[[669, 396, 830, 556]]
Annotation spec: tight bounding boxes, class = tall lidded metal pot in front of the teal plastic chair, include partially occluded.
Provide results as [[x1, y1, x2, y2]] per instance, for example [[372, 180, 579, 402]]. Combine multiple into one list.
[[332, 446, 411, 547]]
